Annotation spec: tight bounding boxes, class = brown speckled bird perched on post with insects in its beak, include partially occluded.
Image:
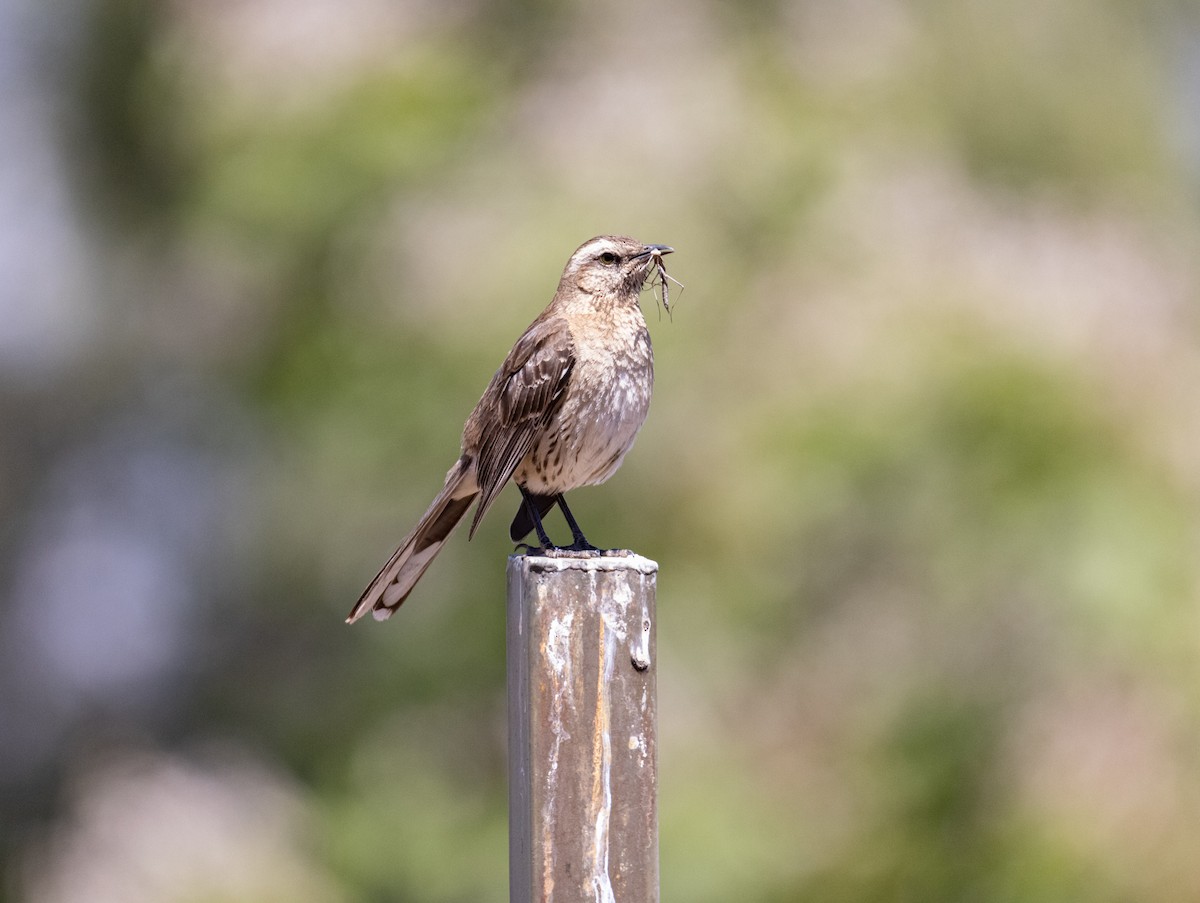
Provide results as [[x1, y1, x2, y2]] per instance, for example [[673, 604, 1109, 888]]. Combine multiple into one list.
[[346, 235, 674, 623]]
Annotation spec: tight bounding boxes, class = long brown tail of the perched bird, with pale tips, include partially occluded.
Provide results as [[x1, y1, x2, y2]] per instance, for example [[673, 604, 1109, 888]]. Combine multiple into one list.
[[346, 459, 479, 624]]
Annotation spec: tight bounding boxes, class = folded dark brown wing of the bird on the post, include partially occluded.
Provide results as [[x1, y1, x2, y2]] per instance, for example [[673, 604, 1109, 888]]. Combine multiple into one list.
[[464, 317, 575, 536]]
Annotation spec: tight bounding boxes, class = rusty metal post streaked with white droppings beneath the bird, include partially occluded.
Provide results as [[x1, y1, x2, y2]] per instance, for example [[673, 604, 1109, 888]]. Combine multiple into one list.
[[508, 555, 659, 903]]
